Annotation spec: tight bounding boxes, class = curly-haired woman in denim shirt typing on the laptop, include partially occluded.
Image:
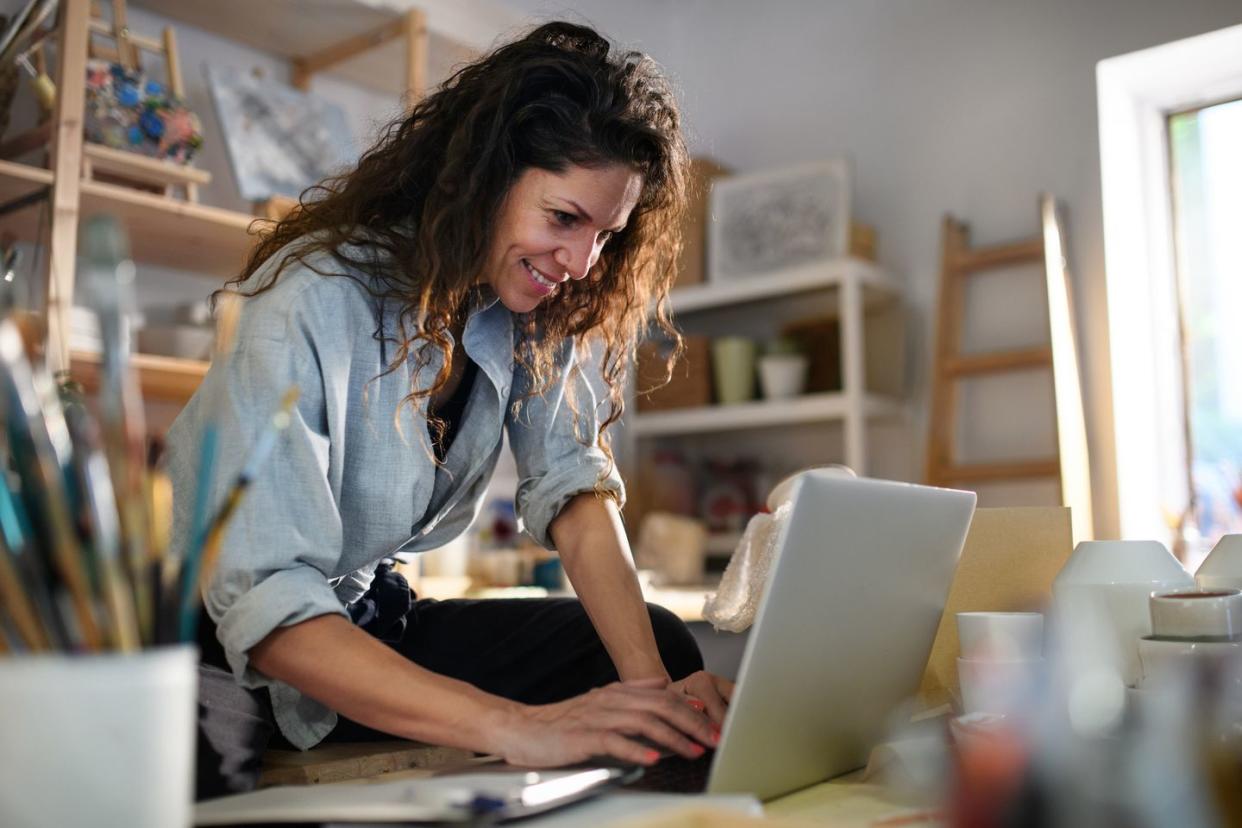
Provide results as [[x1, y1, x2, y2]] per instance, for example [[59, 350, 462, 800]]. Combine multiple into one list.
[[169, 24, 732, 796]]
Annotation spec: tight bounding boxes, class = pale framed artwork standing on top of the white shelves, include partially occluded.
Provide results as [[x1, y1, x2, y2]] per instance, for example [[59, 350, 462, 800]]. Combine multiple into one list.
[[708, 159, 851, 282]]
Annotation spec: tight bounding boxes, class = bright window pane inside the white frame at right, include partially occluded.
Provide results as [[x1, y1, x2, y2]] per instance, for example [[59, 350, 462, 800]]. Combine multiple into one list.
[[1169, 99, 1242, 547]]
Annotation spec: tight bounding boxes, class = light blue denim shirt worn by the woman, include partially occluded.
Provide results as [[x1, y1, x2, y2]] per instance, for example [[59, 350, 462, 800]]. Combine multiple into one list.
[[168, 240, 623, 749]]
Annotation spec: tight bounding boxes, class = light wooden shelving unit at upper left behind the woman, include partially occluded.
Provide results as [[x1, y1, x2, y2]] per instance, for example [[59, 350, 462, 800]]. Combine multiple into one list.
[[0, 0, 509, 402]]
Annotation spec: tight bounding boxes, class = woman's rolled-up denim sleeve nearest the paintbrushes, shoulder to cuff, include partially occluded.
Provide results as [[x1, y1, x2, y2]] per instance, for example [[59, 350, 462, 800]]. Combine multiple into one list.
[[169, 294, 347, 686]]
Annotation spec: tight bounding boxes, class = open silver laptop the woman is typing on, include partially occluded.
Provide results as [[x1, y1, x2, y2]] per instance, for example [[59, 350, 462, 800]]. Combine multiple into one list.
[[636, 472, 975, 799]]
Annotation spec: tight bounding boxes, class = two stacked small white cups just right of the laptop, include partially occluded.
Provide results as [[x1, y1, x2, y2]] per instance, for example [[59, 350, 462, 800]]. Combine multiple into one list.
[[958, 612, 1043, 715]]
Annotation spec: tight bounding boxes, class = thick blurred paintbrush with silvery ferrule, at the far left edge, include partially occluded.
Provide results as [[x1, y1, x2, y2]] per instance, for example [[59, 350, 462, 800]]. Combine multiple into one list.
[[0, 319, 104, 650]]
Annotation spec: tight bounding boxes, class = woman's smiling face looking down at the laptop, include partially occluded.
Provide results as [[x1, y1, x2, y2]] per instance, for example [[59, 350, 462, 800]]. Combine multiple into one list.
[[482, 164, 642, 313]]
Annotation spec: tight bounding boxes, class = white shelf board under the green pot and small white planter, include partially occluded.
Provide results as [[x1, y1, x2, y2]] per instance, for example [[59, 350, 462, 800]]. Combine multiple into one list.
[[630, 392, 902, 437]]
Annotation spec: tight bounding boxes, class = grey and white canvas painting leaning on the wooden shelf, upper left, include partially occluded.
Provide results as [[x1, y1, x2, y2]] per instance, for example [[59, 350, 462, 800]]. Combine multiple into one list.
[[207, 66, 355, 201]]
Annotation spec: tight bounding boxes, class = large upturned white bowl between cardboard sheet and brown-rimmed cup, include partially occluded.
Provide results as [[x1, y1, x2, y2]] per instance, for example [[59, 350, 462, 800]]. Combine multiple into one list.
[[1051, 540, 1195, 685]]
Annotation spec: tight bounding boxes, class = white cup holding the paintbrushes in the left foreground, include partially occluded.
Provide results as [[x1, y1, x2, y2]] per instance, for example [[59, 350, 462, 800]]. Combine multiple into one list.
[[0, 646, 199, 828]]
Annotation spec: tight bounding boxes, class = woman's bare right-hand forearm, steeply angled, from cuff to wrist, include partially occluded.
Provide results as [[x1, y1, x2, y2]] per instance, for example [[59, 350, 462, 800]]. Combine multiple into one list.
[[550, 493, 668, 679]]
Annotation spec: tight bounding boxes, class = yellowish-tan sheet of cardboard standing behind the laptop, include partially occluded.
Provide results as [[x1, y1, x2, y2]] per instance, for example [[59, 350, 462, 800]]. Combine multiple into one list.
[[919, 506, 1073, 708]]
